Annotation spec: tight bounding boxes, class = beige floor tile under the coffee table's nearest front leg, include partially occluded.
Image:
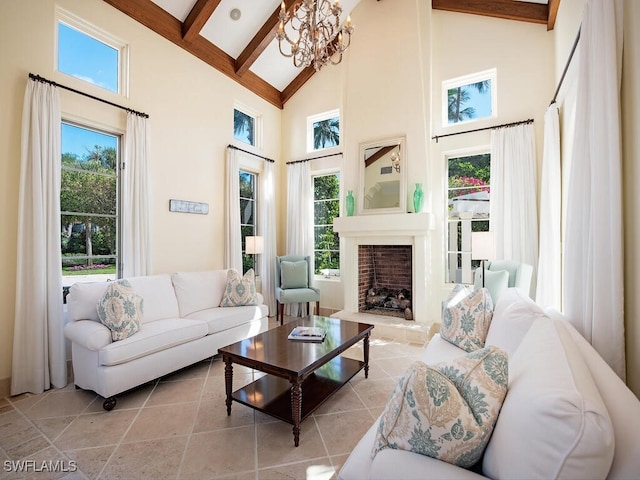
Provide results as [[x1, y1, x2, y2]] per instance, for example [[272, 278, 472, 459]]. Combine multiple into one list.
[[256, 417, 327, 468]]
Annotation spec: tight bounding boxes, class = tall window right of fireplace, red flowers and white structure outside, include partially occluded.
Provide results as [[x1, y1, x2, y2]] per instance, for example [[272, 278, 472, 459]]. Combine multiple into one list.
[[446, 153, 491, 284]]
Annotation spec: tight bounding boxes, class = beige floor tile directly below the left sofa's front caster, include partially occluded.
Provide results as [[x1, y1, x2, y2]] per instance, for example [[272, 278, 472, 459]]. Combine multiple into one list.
[[54, 410, 138, 451]]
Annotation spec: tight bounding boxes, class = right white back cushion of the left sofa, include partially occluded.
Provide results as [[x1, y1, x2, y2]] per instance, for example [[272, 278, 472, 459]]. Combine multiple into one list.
[[171, 270, 227, 317]]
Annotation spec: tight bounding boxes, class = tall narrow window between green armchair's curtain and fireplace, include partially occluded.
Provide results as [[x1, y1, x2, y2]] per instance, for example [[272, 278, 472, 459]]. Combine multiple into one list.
[[313, 173, 340, 277]]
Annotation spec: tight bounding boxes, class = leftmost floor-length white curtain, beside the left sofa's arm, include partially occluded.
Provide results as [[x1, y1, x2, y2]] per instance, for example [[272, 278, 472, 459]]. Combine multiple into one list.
[[11, 80, 67, 395]]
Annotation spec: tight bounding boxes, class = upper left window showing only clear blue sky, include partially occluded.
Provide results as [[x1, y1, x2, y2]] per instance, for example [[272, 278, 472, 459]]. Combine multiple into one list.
[[57, 11, 128, 95]]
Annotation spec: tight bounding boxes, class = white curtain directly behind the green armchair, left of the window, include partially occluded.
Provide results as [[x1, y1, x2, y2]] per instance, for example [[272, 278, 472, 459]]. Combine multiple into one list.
[[287, 162, 314, 316]]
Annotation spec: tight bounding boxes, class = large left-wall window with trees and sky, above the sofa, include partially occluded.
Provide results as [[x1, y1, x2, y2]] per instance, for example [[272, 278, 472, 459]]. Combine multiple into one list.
[[60, 122, 120, 286]]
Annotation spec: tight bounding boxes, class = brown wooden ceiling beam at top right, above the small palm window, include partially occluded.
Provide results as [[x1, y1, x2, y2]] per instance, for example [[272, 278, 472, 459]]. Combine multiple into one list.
[[431, 0, 549, 25]]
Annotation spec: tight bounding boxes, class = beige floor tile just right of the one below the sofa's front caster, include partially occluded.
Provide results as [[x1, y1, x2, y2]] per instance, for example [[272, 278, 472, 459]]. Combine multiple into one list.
[[123, 402, 198, 442]]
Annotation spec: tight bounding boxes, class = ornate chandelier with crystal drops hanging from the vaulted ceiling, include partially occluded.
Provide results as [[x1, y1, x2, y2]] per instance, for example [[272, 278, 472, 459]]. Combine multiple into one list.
[[276, 0, 353, 71]]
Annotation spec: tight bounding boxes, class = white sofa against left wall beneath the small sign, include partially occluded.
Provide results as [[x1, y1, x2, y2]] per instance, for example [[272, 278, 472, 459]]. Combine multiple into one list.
[[64, 270, 268, 410]]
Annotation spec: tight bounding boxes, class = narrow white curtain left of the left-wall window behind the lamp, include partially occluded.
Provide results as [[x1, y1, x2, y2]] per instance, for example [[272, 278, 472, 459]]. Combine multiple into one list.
[[224, 148, 242, 272]]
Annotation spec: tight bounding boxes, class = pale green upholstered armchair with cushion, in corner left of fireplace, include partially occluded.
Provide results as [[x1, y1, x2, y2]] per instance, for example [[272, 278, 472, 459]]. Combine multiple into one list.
[[275, 255, 320, 325]]
